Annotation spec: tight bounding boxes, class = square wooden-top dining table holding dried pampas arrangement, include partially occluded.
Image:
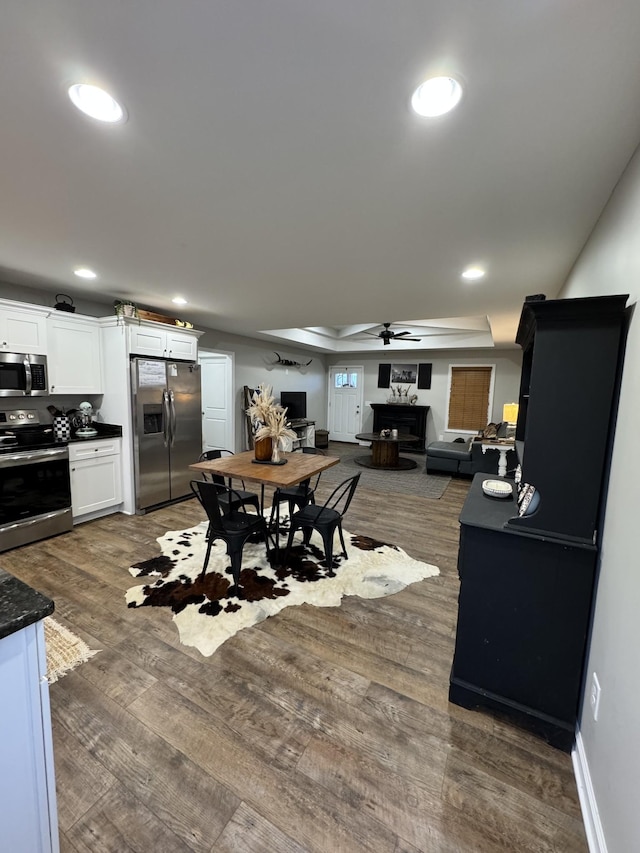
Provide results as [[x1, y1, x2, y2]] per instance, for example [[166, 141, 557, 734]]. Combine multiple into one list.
[[189, 450, 340, 555]]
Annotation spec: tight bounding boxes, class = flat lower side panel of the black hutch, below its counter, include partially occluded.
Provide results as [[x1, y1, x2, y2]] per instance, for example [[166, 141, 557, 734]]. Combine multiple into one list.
[[452, 527, 596, 732]]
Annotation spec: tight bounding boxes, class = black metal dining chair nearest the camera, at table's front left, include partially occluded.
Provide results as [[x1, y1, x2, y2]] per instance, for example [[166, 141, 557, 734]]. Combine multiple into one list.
[[191, 480, 269, 587]]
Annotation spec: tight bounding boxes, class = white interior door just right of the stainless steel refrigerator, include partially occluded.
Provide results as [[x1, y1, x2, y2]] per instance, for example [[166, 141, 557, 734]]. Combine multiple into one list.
[[198, 352, 235, 451]]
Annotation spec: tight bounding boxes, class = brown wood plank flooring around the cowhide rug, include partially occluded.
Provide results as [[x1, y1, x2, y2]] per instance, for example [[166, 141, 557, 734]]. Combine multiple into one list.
[[0, 456, 587, 853]]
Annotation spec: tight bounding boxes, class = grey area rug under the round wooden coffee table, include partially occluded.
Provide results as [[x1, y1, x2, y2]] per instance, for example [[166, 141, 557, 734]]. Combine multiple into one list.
[[321, 441, 451, 500]]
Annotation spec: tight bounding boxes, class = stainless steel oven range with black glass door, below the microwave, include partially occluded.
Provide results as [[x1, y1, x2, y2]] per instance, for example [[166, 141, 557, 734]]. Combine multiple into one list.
[[0, 409, 73, 551]]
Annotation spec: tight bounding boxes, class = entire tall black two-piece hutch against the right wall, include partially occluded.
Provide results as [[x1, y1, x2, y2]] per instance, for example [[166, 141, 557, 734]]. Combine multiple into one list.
[[449, 296, 627, 751]]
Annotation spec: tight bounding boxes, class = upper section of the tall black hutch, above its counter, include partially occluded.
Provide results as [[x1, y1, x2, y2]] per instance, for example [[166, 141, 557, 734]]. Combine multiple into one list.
[[513, 296, 626, 543]]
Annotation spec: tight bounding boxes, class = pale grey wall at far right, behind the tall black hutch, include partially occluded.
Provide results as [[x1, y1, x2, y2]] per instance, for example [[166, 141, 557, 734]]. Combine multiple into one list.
[[560, 146, 640, 853]]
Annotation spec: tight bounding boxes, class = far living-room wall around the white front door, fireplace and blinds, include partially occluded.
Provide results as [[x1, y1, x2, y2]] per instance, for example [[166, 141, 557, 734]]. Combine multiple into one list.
[[327, 347, 522, 443]]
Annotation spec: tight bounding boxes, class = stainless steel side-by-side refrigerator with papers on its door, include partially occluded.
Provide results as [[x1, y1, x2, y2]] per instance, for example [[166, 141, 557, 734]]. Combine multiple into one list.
[[131, 358, 202, 512]]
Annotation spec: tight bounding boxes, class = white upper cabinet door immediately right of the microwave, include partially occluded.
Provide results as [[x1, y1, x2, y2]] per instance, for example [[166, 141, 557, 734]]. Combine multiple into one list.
[[47, 316, 103, 394]]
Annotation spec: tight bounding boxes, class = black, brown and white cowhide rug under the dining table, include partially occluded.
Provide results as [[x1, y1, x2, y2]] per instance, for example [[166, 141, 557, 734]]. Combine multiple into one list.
[[125, 519, 439, 655]]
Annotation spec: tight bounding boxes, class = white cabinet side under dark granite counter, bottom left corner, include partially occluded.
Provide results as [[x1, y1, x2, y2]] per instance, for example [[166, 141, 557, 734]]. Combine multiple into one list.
[[0, 620, 60, 853]]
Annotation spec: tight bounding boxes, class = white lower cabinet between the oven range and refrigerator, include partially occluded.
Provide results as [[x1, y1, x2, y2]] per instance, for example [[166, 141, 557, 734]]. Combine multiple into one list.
[[69, 438, 122, 523]]
